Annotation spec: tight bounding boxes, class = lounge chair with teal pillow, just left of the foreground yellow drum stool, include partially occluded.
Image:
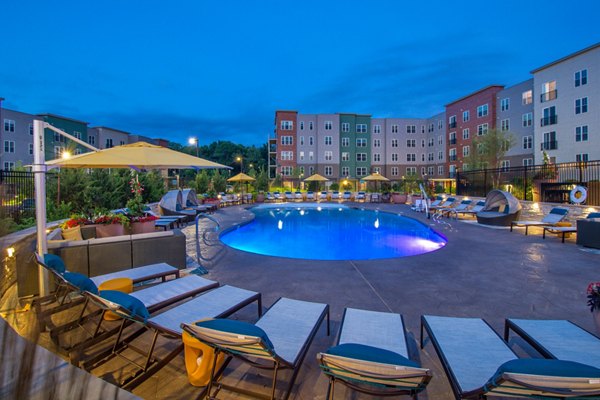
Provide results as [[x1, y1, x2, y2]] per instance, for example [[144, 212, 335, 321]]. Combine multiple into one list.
[[80, 285, 262, 390]]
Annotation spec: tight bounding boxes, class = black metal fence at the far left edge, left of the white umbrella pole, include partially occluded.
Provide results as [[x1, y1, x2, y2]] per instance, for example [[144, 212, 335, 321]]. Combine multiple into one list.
[[0, 170, 35, 222]]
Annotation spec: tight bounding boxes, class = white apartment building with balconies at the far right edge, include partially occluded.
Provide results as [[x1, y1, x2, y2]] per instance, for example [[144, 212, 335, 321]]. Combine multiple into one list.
[[531, 43, 600, 164]]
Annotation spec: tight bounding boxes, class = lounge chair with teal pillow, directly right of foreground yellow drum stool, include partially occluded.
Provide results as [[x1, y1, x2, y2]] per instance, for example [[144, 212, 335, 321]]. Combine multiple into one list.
[[181, 298, 329, 399]]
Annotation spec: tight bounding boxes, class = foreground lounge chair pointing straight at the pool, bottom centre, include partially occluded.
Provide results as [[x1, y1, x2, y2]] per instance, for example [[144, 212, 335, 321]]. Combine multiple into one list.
[[317, 308, 431, 399]]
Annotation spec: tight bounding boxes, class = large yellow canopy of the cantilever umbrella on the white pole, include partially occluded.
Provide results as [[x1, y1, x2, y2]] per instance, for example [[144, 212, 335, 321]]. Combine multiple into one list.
[[46, 142, 231, 170]]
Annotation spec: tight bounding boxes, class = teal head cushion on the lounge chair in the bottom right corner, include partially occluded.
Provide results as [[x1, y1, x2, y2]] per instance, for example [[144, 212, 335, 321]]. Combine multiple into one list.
[[492, 358, 600, 379]]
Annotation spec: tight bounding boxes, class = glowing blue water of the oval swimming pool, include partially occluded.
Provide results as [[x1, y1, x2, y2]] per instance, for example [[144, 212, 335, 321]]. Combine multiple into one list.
[[221, 204, 446, 260]]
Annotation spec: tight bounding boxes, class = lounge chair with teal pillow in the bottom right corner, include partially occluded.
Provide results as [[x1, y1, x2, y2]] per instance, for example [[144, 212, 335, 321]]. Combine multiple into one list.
[[421, 316, 600, 399]]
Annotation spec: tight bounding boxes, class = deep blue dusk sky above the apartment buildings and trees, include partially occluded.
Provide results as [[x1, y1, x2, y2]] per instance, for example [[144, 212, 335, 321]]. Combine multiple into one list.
[[0, 0, 600, 145]]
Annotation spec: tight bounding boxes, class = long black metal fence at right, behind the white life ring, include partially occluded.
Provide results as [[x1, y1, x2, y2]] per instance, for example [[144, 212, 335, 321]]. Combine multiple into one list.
[[456, 161, 600, 206]]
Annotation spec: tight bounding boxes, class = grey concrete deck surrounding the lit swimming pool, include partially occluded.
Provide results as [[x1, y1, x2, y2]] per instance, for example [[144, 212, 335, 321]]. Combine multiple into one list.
[[129, 203, 600, 399]]
